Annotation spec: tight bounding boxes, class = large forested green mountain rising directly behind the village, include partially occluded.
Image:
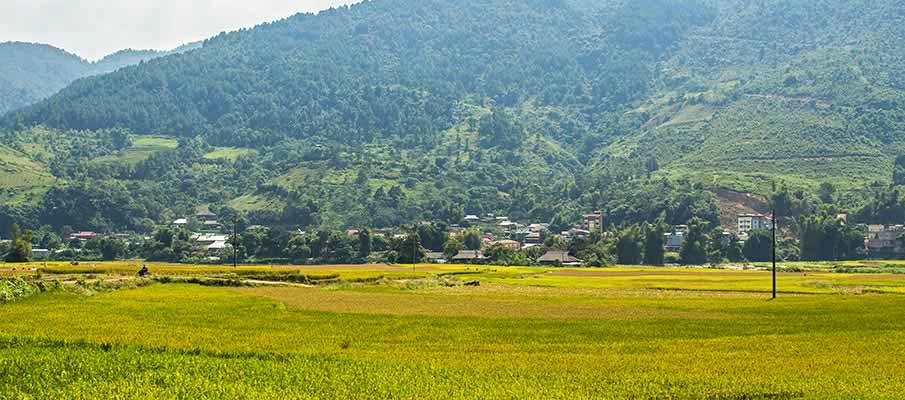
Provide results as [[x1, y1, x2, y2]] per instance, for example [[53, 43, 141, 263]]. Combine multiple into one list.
[[0, 0, 905, 233]]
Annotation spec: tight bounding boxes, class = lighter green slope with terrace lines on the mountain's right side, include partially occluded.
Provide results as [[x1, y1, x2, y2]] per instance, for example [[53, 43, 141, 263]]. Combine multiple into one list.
[[600, 0, 905, 190]]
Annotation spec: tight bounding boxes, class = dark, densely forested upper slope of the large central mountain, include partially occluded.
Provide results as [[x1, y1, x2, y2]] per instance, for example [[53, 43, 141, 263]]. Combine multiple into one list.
[[7, 0, 710, 142]]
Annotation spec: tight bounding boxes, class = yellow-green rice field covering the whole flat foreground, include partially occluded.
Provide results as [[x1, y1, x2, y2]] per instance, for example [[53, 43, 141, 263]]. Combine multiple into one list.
[[0, 262, 905, 399]]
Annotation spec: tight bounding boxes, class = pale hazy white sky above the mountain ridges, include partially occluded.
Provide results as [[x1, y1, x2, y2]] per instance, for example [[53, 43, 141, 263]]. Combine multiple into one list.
[[0, 0, 360, 60]]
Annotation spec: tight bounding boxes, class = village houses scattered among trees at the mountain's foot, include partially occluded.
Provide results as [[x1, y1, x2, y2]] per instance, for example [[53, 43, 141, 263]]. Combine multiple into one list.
[[10, 206, 905, 267]]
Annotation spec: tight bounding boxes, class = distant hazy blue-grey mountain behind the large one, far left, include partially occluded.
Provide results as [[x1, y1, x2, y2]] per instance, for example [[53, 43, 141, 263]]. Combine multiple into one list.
[[0, 42, 200, 114]]
